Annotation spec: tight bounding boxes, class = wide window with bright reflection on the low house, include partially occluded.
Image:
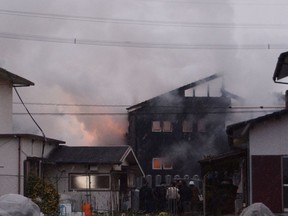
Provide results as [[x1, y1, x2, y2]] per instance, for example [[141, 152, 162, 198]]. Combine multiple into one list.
[[69, 174, 110, 190]]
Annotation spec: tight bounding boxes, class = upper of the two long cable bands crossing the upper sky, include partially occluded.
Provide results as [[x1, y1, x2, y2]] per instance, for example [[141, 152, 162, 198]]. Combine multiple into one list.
[[0, 9, 288, 29]]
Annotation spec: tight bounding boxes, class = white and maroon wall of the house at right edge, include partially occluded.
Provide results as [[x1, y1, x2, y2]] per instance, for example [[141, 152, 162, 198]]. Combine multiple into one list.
[[249, 116, 288, 212]]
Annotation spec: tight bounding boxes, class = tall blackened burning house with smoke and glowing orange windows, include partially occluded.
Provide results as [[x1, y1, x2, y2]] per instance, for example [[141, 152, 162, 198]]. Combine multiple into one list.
[[127, 74, 232, 186]]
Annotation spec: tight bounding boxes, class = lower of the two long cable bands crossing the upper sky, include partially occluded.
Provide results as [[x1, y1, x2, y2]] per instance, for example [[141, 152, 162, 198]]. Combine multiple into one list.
[[0, 32, 288, 50]]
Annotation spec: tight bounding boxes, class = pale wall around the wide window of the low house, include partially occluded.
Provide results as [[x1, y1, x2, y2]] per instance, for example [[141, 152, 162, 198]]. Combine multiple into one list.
[[44, 164, 119, 212]]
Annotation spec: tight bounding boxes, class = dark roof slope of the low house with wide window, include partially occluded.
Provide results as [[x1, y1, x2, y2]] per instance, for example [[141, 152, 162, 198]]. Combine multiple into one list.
[[47, 146, 130, 164]]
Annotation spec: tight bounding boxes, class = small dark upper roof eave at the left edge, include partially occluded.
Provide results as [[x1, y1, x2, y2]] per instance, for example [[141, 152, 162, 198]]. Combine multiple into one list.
[[0, 68, 34, 87]]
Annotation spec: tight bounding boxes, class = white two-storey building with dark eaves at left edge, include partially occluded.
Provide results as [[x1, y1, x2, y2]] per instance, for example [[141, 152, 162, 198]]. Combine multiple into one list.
[[0, 68, 65, 196]]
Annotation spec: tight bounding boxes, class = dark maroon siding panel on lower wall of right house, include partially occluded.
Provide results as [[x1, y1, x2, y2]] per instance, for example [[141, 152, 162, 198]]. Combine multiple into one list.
[[252, 156, 282, 213]]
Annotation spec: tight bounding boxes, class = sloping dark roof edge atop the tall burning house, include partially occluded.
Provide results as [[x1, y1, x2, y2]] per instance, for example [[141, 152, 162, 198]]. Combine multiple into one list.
[[127, 74, 220, 112]]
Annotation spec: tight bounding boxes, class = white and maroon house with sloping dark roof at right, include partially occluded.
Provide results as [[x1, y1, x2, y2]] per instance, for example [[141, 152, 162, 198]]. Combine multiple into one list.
[[227, 109, 288, 213]]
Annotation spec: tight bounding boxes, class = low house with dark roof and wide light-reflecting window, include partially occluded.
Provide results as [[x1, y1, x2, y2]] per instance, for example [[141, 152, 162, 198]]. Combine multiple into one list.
[[44, 145, 144, 212]]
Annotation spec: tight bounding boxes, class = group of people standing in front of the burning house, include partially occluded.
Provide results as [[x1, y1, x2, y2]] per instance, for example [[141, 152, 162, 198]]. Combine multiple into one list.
[[139, 180, 200, 215]]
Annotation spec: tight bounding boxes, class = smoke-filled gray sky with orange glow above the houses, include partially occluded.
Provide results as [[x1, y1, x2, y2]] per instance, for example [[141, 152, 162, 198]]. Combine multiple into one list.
[[0, 0, 288, 145]]
